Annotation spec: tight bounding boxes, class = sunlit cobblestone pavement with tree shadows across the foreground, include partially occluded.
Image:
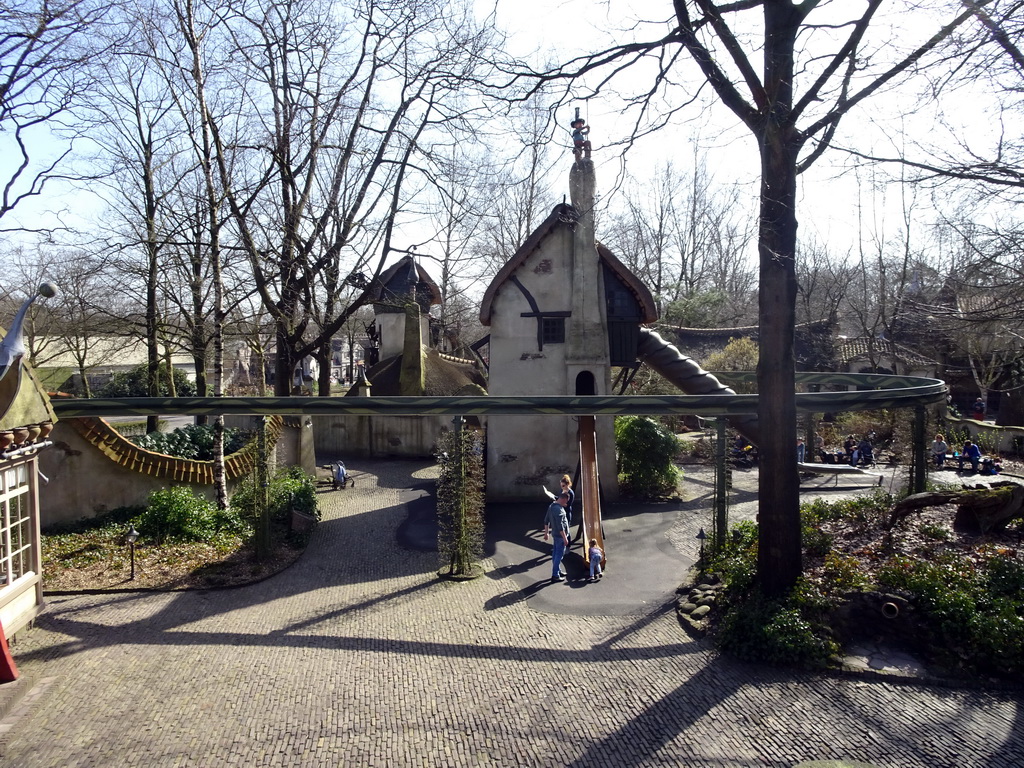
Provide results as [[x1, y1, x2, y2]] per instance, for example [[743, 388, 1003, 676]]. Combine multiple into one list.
[[0, 462, 1024, 768]]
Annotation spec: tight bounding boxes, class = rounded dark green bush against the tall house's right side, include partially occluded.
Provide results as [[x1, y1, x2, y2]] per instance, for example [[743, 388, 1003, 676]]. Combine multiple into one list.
[[615, 416, 681, 498]]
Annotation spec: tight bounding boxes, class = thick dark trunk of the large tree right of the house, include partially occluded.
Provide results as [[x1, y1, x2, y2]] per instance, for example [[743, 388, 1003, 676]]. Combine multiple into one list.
[[758, 3, 803, 596]]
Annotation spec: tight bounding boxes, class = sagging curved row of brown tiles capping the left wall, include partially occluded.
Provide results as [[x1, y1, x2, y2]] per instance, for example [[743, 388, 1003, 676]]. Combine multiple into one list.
[[67, 416, 284, 485]]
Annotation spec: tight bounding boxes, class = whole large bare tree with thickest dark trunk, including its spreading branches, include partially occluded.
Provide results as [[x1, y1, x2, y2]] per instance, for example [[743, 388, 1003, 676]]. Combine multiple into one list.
[[516, 0, 999, 595]]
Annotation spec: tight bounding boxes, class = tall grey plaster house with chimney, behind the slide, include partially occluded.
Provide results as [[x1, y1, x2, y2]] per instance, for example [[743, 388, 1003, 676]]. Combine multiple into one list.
[[480, 160, 657, 501]]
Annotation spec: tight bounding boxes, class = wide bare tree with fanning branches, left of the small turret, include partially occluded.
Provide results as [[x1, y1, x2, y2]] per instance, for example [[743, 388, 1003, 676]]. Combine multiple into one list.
[[197, 0, 497, 394]]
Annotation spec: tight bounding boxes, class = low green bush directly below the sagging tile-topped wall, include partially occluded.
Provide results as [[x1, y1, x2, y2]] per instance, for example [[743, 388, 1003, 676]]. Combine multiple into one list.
[[139, 485, 245, 544]]
